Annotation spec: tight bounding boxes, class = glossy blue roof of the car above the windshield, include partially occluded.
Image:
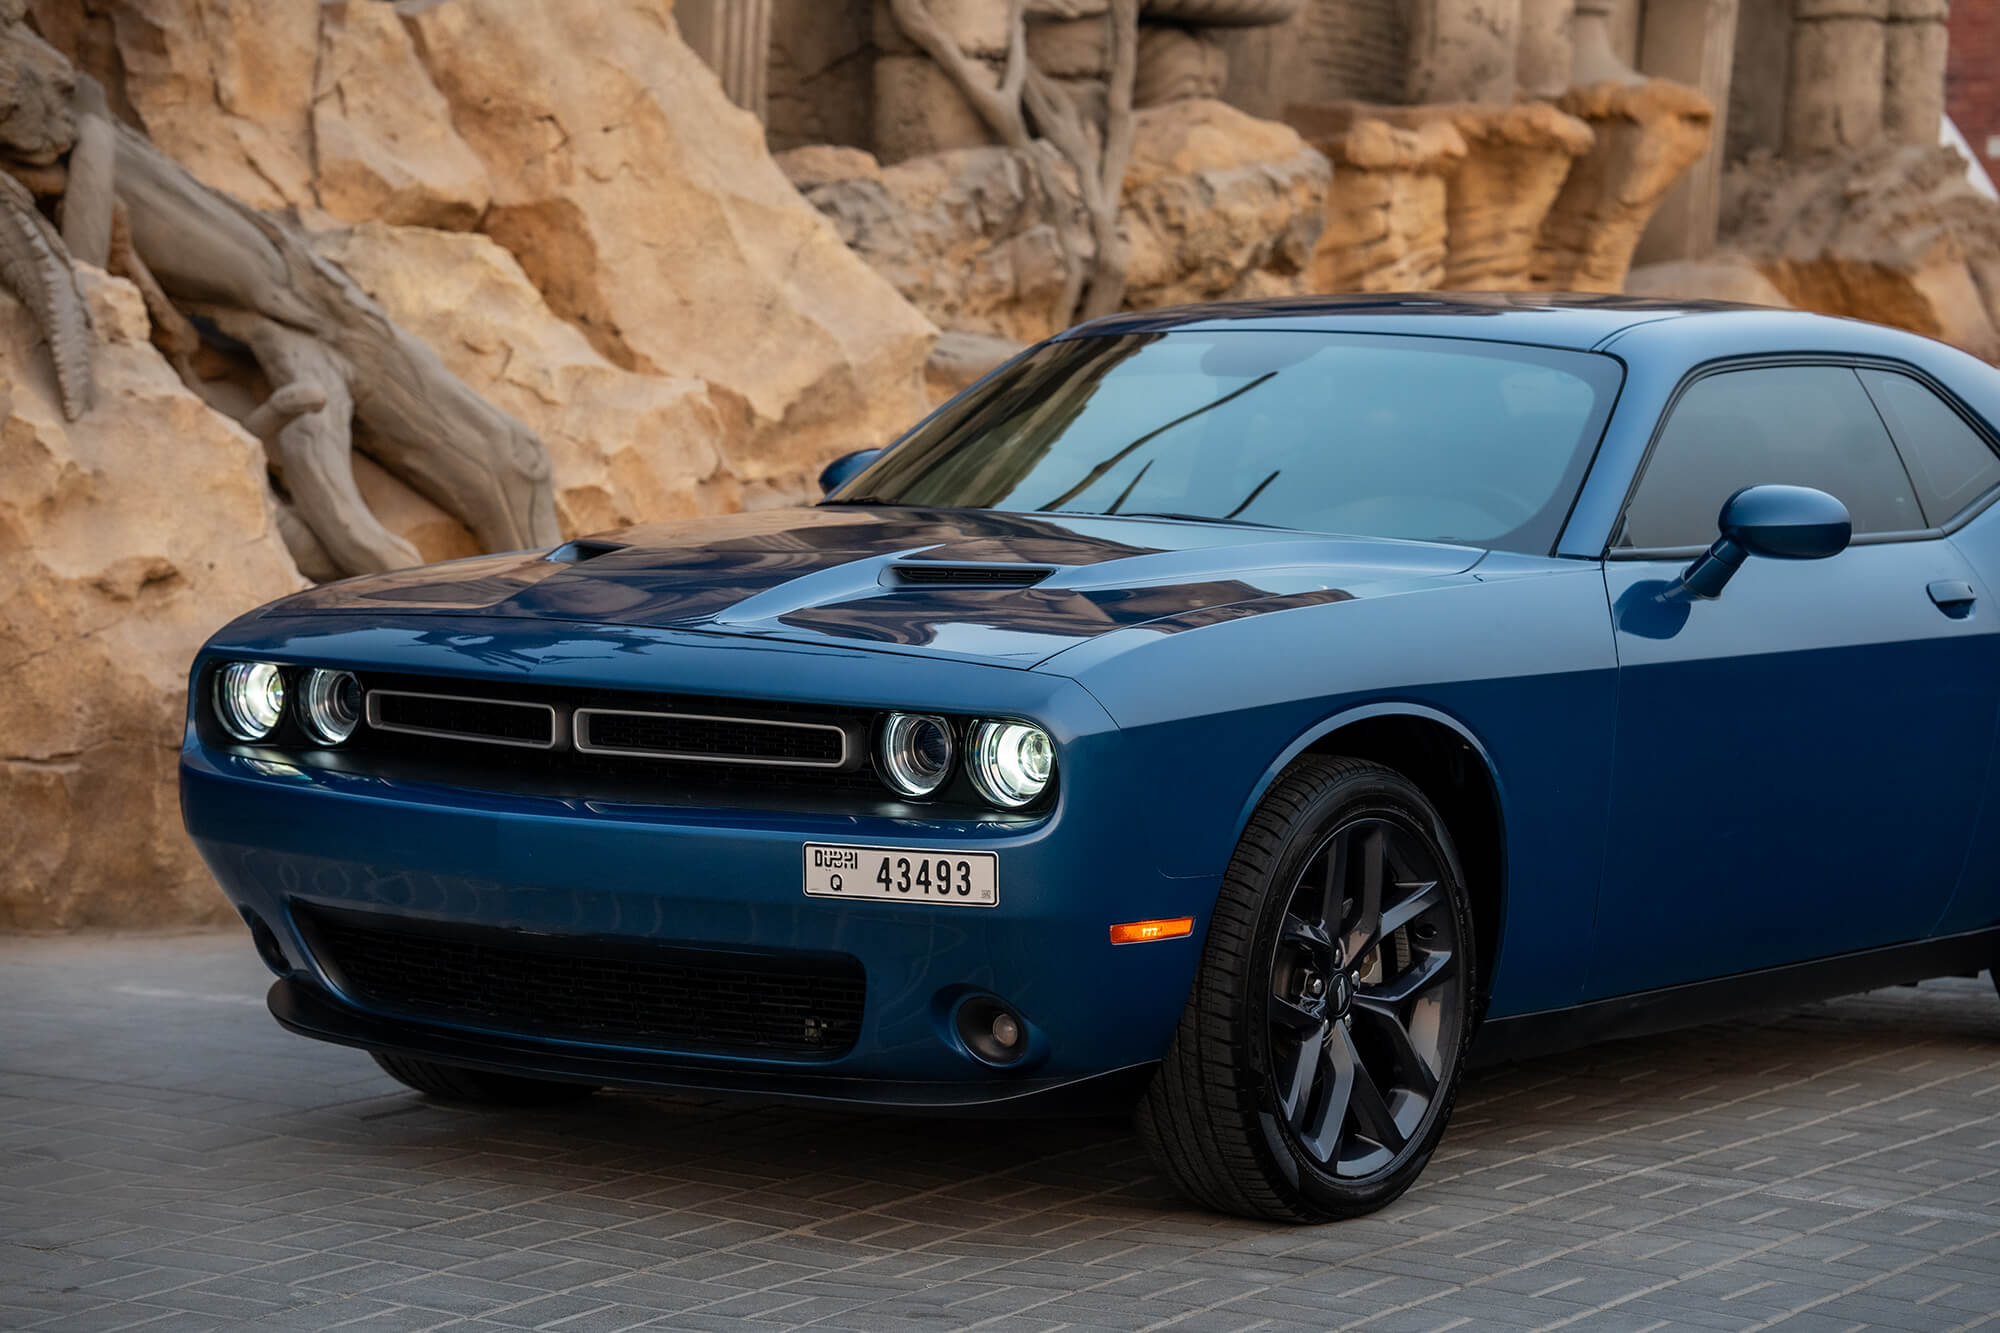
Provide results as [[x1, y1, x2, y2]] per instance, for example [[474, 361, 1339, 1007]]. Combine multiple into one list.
[[1060, 292, 1886, 350]]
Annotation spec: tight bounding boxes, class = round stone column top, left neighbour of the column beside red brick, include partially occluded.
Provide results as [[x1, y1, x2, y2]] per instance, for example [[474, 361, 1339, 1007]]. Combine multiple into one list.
[[1784, 0, 1890, 154]]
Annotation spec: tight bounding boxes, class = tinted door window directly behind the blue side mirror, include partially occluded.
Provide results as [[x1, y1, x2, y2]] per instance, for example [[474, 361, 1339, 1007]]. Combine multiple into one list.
[[1618, 366, 1926, 546]]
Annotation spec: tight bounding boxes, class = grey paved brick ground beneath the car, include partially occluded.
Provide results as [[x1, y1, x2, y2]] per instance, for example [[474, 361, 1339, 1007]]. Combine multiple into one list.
[[0, 924, 2000, 1333]]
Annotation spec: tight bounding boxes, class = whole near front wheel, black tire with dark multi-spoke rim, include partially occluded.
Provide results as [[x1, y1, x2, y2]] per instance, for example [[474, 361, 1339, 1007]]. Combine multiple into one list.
[[1136, 759, 1478, 1223]]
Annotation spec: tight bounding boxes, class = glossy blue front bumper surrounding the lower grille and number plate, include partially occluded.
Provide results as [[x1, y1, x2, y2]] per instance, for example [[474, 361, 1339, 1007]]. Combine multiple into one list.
[[182, 688, 1218, 1111]]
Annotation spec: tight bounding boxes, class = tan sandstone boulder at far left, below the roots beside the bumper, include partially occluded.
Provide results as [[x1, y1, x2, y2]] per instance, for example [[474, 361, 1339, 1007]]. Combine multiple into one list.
[[0, 270, 302, 929]]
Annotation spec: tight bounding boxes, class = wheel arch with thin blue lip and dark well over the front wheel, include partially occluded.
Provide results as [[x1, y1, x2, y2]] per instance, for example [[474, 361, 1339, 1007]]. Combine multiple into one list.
[[1236, 701, 1508, 1013]]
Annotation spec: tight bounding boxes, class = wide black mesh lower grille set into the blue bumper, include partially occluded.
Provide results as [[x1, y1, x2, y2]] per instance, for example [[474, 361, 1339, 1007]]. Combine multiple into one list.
[[292, 903, 868, 1059]]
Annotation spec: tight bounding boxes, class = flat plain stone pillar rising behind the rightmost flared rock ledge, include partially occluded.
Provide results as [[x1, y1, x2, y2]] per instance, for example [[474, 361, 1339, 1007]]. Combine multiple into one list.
[[1634, 0, 1736, 264]]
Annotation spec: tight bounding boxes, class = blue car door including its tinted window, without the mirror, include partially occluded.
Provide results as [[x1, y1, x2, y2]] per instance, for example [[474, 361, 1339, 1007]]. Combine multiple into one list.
[[1586, 364, 2000, 997]]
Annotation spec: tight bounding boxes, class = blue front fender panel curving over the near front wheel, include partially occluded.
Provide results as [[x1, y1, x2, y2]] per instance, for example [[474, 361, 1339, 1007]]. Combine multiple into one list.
[[1040, 558, 1616, 1015]]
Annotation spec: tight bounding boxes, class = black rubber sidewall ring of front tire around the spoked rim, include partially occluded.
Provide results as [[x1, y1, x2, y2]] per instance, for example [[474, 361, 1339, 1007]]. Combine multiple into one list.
[[1236, 769, 1478, 1217]]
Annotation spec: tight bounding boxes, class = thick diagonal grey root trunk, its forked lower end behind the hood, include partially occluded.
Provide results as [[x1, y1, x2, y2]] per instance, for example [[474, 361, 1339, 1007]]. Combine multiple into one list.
[[114, 116, 560, 572]]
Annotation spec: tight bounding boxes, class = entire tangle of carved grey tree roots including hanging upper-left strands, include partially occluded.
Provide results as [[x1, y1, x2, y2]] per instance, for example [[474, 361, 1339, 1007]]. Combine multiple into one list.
[[0, 0, 562, 576]]
